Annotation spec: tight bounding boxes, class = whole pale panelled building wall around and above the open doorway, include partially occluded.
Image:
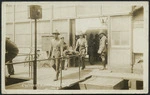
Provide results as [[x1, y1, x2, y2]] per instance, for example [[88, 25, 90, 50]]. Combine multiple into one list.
[[3, 3, 148, 72]]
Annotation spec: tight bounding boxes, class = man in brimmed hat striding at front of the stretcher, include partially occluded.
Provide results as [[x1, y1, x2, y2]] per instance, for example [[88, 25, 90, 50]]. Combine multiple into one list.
[[50, 30, 63, 81]]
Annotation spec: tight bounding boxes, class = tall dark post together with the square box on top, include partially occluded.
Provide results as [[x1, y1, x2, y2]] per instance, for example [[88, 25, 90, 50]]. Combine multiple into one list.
[[29, 5, 42, 90]]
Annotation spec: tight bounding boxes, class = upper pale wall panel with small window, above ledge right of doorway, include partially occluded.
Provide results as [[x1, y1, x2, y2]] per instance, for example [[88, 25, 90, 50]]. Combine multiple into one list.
[[111, 16, 131, 47]]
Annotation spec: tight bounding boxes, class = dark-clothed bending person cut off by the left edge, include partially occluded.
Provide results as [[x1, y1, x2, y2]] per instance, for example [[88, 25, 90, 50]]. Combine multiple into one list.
[[5, 37, 19, 75]]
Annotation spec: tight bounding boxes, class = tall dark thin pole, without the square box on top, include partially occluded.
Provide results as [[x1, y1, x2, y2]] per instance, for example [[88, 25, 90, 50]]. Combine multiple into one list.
[[33, 19, 37, 90]]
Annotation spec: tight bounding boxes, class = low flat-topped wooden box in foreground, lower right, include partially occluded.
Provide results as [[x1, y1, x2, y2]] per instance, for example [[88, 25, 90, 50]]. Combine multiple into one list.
[[79, 76, 124, 90]]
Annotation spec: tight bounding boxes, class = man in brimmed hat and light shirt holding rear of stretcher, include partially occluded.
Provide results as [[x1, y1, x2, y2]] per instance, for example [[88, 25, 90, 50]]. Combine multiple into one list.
[[75, 32, 87, 70]]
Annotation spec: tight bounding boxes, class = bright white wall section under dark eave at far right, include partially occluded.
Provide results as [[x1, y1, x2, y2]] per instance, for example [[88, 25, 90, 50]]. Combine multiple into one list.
[[133, 8, 145, 53]]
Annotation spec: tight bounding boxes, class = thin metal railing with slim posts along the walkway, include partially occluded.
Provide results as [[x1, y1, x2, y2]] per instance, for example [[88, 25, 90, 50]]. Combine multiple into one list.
[[5, 54, 80, 88]]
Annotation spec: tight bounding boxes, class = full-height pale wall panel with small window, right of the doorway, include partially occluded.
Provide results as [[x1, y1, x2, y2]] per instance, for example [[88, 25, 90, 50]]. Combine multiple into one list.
[[109, 16, 132, 72]]
